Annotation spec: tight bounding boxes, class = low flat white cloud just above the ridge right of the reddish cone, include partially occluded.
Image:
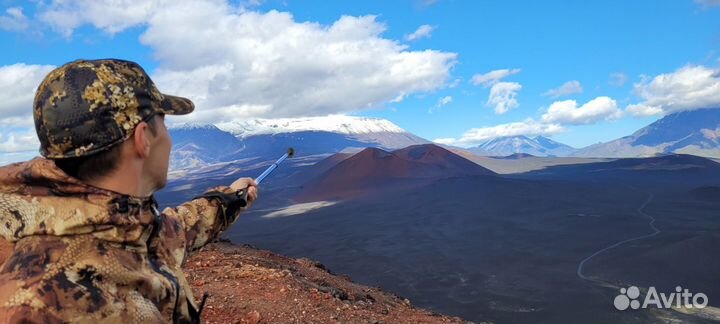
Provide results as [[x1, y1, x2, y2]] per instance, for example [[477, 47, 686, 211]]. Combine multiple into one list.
[[434, 118, 565, 147]]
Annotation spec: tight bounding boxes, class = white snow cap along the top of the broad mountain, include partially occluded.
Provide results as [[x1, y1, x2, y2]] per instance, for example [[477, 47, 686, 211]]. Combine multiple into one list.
[[218, 115, 406, 137]]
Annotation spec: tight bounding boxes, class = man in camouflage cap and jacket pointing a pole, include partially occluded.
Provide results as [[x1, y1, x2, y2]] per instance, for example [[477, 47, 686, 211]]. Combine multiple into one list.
[[0, 60, 257, 323]]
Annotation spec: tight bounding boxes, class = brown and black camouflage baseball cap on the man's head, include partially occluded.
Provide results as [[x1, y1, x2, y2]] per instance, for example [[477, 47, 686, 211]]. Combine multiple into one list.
[[33, 59, 194, 159]]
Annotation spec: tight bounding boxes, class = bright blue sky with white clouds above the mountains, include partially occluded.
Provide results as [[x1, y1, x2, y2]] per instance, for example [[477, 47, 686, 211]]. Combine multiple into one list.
[[0, 0, 720, 159]]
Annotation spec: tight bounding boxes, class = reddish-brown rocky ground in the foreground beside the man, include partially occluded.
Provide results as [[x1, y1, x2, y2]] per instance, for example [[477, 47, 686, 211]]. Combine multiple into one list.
[[185, 242, 466, 324]]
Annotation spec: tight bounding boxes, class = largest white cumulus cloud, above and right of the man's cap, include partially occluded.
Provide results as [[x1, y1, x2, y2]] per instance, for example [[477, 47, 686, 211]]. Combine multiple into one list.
[[22, 0, 457, 123]]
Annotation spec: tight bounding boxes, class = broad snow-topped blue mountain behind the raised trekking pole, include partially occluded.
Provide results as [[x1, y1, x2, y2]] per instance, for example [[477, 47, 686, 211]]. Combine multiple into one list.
[[170, 116, 430, 169]]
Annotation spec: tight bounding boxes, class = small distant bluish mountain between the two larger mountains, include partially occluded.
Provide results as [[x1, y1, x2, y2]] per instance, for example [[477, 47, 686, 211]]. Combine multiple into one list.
[[468, 136, 575, 156]]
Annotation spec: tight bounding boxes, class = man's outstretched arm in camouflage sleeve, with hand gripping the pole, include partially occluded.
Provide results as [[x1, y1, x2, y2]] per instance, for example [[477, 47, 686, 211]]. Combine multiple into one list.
[[163, 178, 257, 251]]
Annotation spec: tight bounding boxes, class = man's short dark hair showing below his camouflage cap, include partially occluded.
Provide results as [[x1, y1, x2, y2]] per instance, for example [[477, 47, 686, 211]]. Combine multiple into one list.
[[55, 115, 158, 181]]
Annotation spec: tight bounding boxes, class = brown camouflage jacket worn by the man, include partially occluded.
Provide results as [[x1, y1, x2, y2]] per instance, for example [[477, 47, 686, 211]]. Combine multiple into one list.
[[0, 158, 245, 324]]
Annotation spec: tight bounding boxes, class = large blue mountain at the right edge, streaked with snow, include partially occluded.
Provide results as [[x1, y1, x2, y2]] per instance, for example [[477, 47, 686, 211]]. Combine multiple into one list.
[[574, 109, 720, 158]]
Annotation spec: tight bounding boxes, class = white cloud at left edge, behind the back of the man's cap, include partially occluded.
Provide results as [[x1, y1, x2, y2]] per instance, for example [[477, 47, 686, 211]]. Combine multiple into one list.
[[0, 63, 54, 128]]
